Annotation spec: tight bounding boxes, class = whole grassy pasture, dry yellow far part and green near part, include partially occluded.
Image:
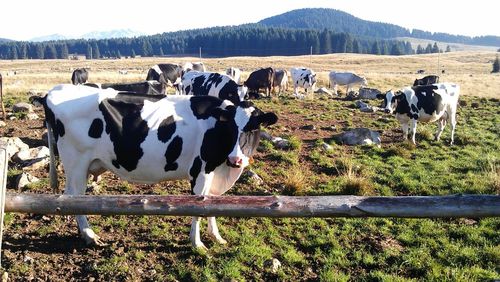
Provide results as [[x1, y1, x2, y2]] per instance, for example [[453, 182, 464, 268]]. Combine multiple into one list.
[[0, 52, 500, 281]]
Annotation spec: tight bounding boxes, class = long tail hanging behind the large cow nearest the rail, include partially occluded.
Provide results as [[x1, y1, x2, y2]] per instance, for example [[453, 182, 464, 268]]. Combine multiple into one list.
[[29, 96, 59, 194]]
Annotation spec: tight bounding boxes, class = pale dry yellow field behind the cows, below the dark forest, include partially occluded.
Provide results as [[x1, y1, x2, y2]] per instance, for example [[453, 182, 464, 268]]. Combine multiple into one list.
[[0, 51, 500, 97]]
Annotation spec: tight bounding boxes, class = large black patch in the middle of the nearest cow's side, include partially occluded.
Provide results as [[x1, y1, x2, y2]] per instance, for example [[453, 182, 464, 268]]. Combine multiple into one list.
[[99, 94, 151, 171]]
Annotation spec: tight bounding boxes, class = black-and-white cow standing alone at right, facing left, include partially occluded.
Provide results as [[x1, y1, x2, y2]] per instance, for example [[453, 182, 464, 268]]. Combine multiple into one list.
[[378, 83, 460, 145]]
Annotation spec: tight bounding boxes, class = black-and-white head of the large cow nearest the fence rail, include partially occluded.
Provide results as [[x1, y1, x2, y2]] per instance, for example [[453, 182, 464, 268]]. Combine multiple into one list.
[[226, 101, 278, 168]]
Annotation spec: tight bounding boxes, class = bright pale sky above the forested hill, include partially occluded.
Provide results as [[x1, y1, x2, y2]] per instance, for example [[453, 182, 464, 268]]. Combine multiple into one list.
[[0, 0, 500, 40]]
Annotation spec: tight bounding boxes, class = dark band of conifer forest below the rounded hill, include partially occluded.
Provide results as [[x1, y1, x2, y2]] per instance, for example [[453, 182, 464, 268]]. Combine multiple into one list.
[[0, 24, 415, 59]]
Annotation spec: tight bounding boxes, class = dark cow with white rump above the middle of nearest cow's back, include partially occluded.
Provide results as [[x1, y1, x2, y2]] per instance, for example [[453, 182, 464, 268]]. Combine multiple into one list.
[[146, 64, 183, 94]]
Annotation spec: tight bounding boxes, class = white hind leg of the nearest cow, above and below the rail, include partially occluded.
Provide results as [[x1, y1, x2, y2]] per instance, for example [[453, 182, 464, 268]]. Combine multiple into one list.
[[63, 157, 104, 246]]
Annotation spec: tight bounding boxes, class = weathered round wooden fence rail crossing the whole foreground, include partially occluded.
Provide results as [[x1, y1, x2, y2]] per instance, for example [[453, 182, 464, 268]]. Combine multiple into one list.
[[5, 193, 500, 218]]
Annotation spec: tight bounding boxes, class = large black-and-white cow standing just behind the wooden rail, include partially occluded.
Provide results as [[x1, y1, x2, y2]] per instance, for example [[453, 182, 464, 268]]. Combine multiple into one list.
[[36, 84, 278, 248]]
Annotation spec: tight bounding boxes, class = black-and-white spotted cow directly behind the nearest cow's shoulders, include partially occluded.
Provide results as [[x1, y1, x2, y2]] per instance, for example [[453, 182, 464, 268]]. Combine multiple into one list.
[[182, 71, 247, 105]]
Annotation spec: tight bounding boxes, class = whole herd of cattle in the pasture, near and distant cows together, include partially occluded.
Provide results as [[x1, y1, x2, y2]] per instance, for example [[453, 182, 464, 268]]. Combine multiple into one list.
[[27, 63, 460, 248]]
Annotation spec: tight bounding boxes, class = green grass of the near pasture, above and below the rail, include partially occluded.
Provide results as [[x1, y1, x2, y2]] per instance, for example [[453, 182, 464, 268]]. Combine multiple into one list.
[[1, 95, 500, 281]]
